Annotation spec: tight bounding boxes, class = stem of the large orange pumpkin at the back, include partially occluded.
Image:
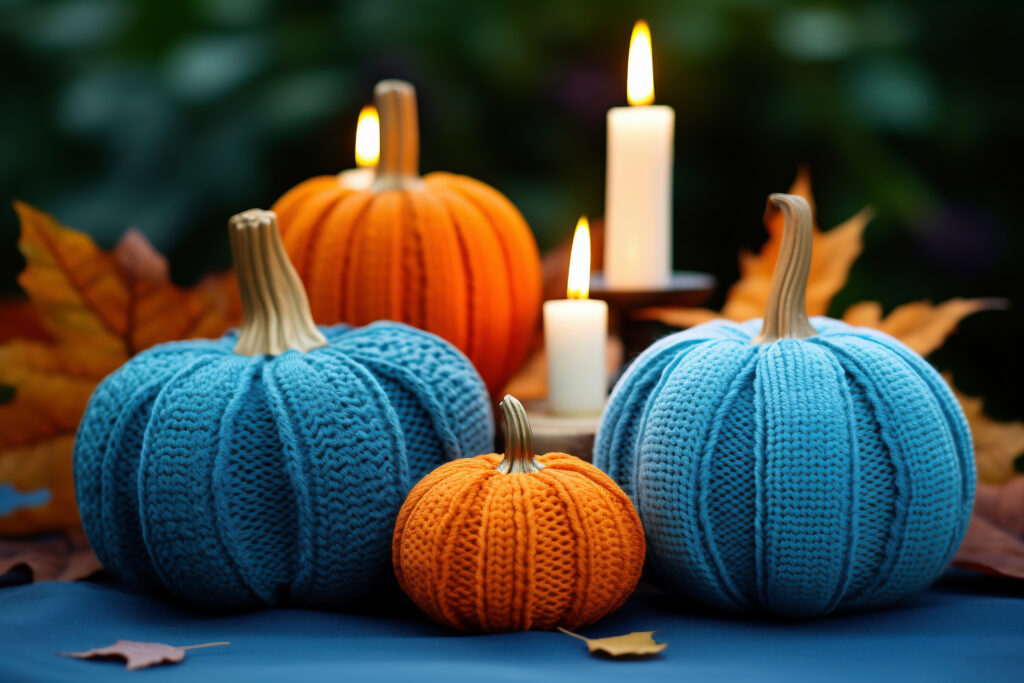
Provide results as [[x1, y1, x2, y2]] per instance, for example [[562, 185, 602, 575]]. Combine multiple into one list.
[[372, 79, 423, 193]]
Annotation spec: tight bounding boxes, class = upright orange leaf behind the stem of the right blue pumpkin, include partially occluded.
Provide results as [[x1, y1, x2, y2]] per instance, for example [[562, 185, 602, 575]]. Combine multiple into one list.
[[637, 168, 873, 328]]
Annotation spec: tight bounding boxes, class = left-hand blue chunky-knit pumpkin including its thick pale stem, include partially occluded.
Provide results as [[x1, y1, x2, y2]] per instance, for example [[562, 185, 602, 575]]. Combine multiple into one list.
[[74, 212, 494, 607]]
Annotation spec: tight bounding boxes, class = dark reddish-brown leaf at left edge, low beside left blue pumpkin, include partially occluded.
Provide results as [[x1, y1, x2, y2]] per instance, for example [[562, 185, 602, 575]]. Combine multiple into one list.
[[0, 531, 103, 581]]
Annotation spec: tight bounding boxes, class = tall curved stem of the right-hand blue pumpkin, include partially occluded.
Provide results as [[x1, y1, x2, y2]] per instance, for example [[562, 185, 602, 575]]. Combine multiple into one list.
[[754, 194, 818, 344]]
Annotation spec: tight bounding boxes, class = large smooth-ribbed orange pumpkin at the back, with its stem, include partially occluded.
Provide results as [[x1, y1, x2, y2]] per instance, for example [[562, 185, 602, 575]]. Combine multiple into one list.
[[273, 81, 541, 394]]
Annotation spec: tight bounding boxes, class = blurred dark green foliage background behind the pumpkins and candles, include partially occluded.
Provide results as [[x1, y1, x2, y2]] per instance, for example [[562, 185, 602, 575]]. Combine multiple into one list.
[[0, 0, 1024, 418]]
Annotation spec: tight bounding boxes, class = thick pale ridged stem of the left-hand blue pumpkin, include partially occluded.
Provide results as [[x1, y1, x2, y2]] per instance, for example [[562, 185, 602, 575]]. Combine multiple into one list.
[[227, 209, 327, 355]]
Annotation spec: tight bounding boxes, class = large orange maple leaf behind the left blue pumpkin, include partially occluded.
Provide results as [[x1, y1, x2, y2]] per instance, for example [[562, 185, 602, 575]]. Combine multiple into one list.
[[0, 202, 241, 535]]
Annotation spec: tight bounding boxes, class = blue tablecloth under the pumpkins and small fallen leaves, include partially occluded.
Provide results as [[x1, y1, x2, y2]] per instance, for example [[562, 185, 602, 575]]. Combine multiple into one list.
[[0, 572, 1024, 683]]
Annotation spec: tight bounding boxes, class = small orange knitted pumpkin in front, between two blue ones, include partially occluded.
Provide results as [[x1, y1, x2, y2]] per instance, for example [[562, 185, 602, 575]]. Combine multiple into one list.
[[392, 396, 645, 631]]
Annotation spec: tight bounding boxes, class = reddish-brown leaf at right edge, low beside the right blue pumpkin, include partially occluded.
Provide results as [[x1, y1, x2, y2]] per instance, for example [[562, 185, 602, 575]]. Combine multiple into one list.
[[953, 475, 1024, 579]]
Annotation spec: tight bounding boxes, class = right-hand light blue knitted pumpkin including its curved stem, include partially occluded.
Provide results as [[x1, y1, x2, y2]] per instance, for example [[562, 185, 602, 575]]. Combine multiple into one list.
[[595, 195, 975, 616]]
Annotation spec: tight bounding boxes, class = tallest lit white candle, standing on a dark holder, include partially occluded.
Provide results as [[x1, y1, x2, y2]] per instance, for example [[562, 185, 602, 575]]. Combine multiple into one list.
[[604, 20, 676, 290]]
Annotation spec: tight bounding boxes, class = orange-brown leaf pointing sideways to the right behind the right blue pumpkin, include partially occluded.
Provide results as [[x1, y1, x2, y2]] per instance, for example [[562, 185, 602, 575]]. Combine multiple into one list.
[[843, 298, 1007, 355]]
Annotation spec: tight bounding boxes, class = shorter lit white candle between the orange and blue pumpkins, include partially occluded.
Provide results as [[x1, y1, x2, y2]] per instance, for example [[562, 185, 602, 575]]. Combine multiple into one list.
[[544, 217, 608, 416]]
